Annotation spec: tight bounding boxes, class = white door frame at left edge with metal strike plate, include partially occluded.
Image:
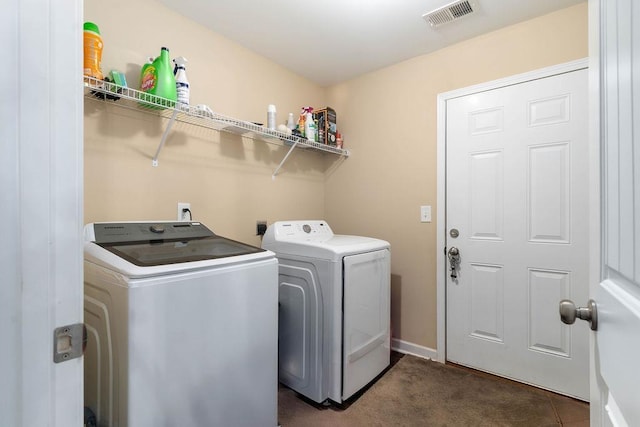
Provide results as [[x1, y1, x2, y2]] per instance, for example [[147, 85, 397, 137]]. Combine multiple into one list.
[[0, 0, 83, 427]]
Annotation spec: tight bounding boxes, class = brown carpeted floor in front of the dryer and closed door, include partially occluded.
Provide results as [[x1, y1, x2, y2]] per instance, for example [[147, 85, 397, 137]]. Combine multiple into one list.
[[278, 356, 589, 427]]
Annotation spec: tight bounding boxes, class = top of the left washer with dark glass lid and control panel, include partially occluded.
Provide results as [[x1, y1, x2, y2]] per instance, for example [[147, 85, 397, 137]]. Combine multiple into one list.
[[84, 221, 274, 278]]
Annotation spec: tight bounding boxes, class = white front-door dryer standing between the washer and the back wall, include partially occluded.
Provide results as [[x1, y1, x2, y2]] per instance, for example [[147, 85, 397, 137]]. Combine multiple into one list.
[[262, 221, 391, 403]]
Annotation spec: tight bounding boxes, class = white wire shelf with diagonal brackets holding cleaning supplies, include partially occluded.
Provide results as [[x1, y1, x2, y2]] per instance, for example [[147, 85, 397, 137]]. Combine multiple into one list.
[[84, 76, 350, 170]]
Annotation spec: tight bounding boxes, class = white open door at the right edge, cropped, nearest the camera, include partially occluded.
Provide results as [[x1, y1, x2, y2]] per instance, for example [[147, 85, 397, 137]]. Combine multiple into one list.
[[588, 0, 640, 426]]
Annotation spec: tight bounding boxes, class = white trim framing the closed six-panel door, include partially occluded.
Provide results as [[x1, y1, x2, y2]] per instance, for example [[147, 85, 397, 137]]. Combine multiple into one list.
[[436, 58, 589, 363]]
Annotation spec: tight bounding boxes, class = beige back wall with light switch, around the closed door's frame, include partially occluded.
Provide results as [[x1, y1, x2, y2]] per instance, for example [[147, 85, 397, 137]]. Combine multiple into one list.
[[325, 3, 588, 349]]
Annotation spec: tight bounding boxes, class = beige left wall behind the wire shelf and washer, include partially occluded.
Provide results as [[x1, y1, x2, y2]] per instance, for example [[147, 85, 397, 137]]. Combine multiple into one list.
[[84, 0, 336, 245]]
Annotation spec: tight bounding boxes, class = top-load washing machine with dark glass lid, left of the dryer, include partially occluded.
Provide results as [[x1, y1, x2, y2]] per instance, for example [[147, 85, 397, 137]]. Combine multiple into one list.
[[84, 222, 278, 427]]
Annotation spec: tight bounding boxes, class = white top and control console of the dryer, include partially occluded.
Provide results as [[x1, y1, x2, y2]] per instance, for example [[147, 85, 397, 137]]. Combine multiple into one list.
[[262, 220, 390, 261]]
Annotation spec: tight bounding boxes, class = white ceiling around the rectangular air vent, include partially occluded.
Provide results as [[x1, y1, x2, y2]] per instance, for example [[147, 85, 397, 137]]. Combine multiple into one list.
[[158, 0, 585, 86]]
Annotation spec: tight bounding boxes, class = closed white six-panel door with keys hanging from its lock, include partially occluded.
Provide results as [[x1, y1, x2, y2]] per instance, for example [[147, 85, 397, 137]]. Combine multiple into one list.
[[446, 69, 589, 400]]
